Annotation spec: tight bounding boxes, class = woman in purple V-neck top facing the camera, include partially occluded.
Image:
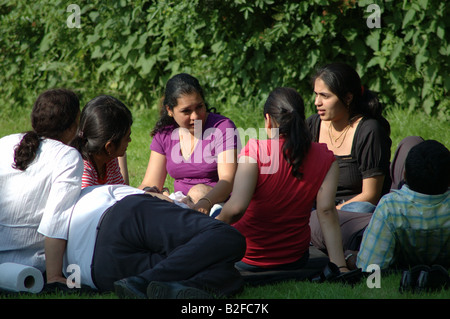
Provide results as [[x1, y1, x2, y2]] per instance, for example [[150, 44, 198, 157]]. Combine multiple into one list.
[[139, 73, 239, 214]]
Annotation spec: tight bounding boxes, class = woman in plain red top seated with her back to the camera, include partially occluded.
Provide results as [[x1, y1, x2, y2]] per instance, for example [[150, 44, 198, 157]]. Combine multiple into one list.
[[217, 88, 348, 272]]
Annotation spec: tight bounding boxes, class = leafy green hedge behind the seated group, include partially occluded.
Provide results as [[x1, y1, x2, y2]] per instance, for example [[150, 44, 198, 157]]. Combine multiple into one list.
[[0, 0, 450, 120]]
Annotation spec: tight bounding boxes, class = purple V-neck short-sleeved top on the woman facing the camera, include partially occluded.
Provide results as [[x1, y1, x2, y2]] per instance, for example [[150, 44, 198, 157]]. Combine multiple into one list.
[[150, 113, 240, 195]]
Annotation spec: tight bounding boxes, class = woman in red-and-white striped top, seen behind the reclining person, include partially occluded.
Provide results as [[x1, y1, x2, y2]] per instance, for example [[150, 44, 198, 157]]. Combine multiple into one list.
[[71, 95, 133, 188]]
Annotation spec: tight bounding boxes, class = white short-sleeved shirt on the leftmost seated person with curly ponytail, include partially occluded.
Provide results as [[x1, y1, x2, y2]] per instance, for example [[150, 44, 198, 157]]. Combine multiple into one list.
[[0, 134, 83, 271]]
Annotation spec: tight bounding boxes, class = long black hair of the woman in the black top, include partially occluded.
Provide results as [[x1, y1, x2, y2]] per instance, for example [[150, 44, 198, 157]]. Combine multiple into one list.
[[312, 62, 391, 135]]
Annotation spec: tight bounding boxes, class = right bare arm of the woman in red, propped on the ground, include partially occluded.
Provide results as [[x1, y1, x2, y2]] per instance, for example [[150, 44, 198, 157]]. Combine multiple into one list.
[[317, 162, 348, 271]]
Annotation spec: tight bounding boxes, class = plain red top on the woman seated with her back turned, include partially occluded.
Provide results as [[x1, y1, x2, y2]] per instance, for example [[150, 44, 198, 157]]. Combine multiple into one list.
[[233, 139, 335, 267]]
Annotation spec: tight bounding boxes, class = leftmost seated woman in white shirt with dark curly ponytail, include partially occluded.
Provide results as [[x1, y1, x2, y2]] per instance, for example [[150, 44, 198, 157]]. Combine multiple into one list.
[[0, 89, 83, 283]]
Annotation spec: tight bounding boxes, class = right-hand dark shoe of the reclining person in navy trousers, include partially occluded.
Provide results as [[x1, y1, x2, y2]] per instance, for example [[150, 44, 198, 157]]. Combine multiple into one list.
[[147, 281, 213, 299]]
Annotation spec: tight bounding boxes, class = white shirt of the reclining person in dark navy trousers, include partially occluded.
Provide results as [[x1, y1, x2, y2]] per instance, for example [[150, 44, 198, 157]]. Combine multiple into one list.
[[63, 185, 145, 288]]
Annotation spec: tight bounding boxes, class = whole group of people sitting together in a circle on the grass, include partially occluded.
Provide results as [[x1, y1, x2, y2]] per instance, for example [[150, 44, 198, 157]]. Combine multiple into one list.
[[0, 62, 450, 299]]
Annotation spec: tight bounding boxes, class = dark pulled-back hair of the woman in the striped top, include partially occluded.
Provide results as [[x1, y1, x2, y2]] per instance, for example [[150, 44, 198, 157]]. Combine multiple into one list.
[[71, 95, 133, 160]]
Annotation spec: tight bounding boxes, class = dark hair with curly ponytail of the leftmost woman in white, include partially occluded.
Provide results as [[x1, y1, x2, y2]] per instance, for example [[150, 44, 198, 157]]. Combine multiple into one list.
[[12, 89, 80, 171]]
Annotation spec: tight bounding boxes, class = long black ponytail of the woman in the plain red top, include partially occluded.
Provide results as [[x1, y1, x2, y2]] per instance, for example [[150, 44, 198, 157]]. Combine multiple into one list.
[[264, 87, 312, 179]]
